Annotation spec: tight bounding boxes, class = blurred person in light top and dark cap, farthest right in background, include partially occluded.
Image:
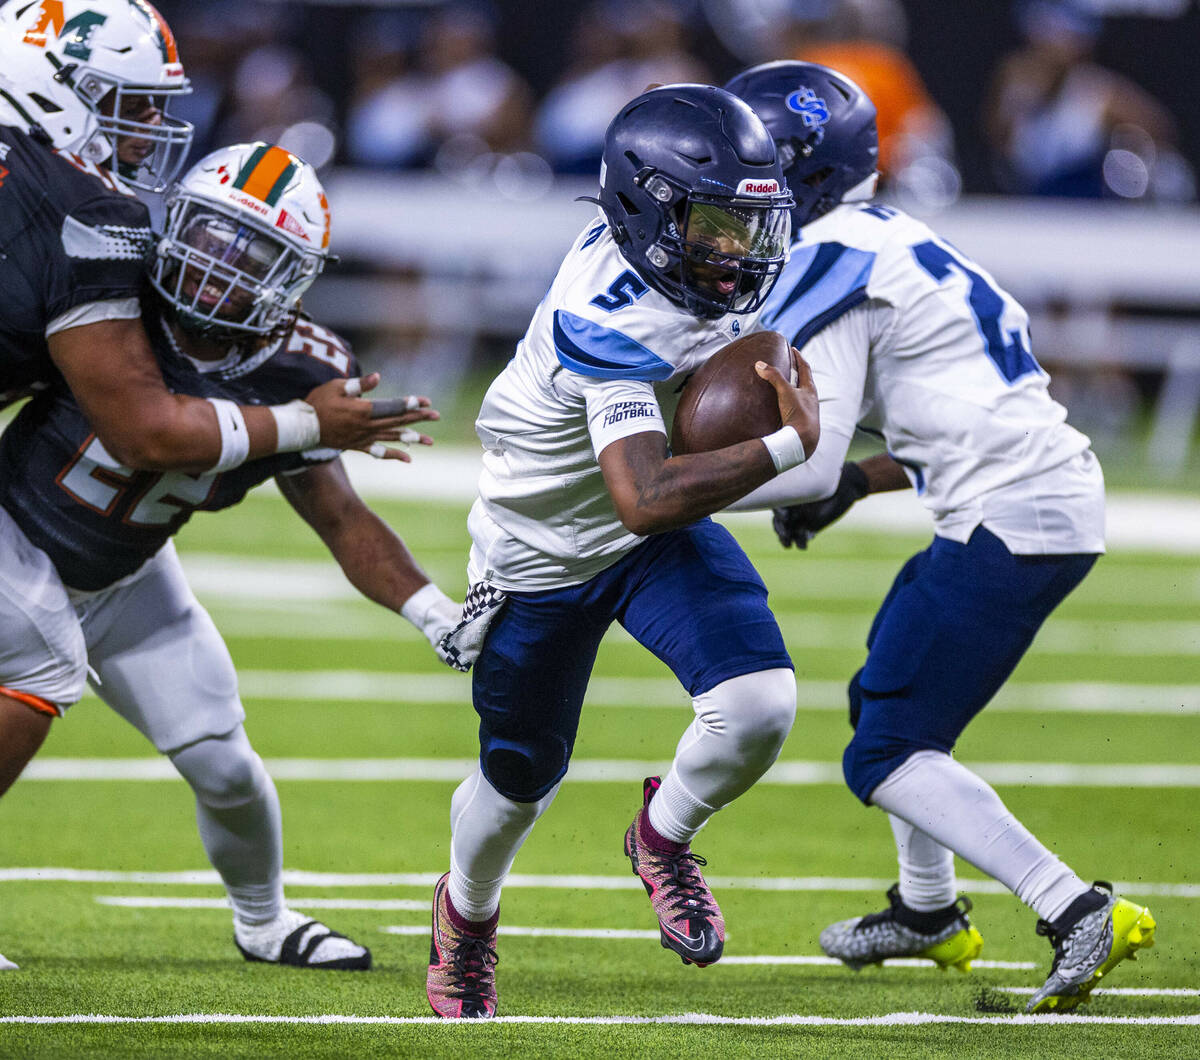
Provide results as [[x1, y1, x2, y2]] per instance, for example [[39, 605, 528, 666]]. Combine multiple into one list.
[[986, 0, 1195, 199]]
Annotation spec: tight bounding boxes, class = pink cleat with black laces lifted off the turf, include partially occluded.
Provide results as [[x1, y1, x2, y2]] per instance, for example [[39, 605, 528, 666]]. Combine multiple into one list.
[[625, 777, 725, 968]]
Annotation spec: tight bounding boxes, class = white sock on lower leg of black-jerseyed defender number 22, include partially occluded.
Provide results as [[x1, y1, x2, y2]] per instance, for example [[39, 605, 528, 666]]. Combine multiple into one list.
[[170, 727, 283, 924]]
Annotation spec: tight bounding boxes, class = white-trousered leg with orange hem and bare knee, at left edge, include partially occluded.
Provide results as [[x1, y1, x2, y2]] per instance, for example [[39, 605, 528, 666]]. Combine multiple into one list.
[[0, 509, 88, 795]]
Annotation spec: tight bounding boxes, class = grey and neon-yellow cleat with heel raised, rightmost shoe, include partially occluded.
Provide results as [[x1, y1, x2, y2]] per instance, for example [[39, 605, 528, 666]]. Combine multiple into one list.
[[1025, 880, 1156, 1012]]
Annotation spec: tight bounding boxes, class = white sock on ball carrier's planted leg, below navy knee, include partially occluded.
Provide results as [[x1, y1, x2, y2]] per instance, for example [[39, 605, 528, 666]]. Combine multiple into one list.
[[449, 768, 559, 922]]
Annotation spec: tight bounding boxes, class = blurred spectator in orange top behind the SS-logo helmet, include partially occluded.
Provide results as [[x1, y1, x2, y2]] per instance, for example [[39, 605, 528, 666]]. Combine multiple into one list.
[[778, 0, 962, 211]]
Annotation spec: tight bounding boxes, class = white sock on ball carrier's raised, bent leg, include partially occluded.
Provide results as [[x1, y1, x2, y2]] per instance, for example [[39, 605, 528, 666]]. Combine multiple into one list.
[[649, 669, 796, 843]]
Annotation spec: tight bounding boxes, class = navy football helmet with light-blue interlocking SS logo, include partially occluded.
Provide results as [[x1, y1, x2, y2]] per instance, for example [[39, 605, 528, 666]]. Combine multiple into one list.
[[725, 61, 880, 229]]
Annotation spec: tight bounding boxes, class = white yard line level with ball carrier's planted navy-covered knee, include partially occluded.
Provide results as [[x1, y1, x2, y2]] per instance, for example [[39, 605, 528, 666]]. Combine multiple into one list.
[[22, 756, 1200, 789]]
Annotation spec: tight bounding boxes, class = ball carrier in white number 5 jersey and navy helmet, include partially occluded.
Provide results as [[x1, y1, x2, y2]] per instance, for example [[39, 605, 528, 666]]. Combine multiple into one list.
[[427, 85, 818, 1018]]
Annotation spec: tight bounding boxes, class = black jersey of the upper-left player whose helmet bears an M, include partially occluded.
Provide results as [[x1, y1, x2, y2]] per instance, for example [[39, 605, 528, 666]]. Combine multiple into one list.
[[0, 125, 151, 405]]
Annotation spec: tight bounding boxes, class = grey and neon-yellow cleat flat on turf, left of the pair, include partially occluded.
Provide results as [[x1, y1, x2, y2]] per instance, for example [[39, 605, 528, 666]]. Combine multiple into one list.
[[820, 884, 983, 972]]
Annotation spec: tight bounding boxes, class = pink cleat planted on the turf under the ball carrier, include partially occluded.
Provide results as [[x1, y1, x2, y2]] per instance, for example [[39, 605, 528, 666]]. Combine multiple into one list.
[[425, 873, 500, 1019]]
